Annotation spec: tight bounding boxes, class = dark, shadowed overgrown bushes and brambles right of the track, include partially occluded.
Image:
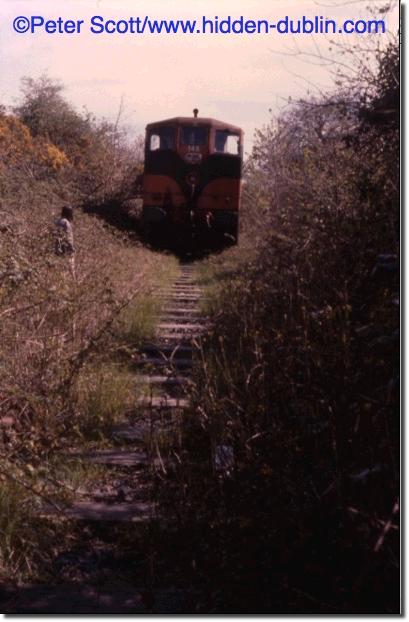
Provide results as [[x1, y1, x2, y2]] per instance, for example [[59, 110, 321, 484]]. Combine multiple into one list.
[[166, 35, 399, 613]]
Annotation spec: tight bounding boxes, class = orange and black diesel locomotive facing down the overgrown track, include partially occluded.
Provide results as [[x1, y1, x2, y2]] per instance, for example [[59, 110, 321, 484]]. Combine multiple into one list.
[[141, 109, 243, 247]]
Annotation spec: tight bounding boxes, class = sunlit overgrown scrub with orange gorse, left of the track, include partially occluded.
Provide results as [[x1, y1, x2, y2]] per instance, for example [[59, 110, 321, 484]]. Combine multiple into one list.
[[0, 78, 176, 576]]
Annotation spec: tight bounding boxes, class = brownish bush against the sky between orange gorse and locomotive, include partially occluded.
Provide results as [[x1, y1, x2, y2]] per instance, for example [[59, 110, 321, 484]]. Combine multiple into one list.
[[14, 76, 142, 205]]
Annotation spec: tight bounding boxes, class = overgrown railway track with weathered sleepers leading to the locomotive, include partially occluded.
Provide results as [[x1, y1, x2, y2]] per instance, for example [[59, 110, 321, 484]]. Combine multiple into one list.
[[2, 264, 207, 614]]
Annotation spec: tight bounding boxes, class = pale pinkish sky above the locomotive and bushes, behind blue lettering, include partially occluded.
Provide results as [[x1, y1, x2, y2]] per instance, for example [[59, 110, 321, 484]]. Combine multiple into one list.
[[0, 0, 398, 151]]
